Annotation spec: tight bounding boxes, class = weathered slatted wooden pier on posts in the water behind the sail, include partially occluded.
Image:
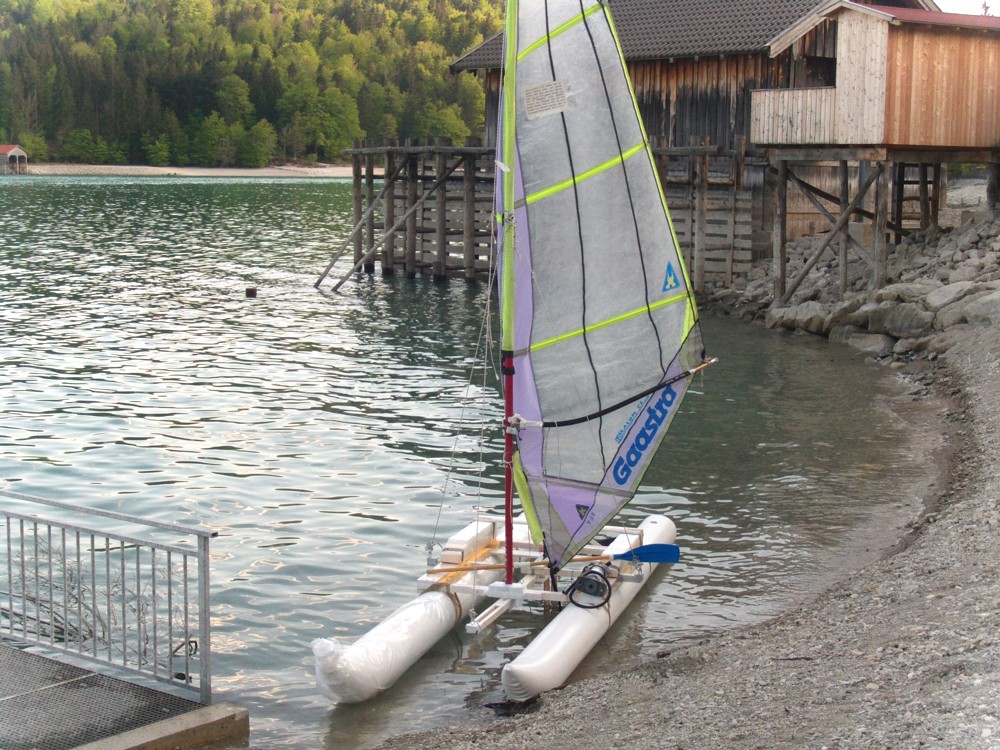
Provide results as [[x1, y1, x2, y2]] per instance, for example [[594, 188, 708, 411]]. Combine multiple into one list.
[[316, 139, 759, 292]]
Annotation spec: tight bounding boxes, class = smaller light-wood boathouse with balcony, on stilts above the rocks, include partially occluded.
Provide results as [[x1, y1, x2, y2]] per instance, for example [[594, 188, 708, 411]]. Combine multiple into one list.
[[750, 0, 1000, 302]]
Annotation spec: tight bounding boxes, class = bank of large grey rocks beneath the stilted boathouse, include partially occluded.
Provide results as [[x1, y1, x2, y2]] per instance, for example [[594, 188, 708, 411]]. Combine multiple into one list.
[[710, 207, 1000, 362]]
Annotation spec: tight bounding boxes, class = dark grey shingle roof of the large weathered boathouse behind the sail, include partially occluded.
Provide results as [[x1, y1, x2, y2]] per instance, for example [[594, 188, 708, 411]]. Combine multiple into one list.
[[452, 0, 822, 70]]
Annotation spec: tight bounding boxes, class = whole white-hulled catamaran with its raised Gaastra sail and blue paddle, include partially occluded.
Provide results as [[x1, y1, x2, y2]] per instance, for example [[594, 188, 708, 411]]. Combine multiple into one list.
[[313, 0, 714, 702]]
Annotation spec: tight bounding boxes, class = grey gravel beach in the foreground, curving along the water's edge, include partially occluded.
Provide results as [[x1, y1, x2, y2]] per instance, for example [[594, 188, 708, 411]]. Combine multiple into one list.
[[381, 198, 1000, 750]]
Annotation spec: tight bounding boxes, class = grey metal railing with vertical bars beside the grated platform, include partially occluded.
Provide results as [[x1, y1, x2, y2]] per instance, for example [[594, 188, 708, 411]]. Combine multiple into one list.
[[0, 490, 217, 704]]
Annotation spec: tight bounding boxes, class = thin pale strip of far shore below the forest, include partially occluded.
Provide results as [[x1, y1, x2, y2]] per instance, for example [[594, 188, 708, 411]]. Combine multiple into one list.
[[27, 163, 353, 179]]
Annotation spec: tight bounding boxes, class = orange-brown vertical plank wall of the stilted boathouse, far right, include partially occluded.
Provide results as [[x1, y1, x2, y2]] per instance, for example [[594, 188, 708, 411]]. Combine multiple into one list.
[[885, 25, 1000, 148]]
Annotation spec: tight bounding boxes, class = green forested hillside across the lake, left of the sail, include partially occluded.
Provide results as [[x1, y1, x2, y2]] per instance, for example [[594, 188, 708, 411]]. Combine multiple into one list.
[[0, 0, 503, 167]]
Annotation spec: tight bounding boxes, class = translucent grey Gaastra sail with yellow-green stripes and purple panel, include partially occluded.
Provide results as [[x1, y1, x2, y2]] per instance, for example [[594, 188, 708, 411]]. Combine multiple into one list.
[[497, 0, 703, 569]]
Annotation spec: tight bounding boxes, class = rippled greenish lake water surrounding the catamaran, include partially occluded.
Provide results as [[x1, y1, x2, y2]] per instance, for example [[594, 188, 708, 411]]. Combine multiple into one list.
[[0, 177, 932, 749]]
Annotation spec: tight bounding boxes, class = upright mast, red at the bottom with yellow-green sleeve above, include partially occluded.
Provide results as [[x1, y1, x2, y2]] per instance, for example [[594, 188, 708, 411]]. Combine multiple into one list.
[[497, 0, 518, 584]]
